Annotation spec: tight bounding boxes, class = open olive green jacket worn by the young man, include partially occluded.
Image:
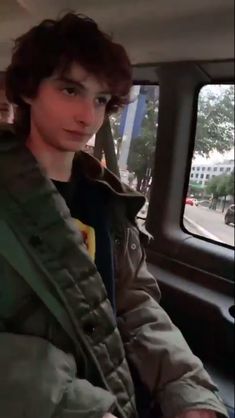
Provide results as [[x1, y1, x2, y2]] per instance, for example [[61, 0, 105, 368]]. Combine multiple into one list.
[[0, 127, 226, 418]]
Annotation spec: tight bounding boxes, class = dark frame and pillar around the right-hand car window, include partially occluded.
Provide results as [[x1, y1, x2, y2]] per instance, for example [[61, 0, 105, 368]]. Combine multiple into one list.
[[132, 63, 234, 287]]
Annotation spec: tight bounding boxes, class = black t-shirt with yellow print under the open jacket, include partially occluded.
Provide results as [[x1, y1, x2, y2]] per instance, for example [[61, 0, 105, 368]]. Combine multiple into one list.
[[53, 169, 115, 310]]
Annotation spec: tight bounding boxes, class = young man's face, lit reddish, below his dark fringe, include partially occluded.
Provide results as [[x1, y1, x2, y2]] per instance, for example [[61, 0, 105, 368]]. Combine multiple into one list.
[[25, 64, 111, 152]]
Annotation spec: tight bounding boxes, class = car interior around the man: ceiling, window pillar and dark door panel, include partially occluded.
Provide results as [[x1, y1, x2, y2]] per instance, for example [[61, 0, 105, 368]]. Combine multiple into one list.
[[0, 0, 234, 417]]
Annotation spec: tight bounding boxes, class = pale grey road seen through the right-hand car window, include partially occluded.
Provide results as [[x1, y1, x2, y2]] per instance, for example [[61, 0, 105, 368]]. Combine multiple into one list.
[[184, 205, 234, 246]]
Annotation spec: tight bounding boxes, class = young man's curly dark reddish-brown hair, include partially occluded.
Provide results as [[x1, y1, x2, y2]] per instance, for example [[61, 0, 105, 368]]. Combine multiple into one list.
[[5, 12, 132, 135]]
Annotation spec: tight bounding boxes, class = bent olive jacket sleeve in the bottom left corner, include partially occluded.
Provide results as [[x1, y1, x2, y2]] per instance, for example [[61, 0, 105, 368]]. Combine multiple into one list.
[[0, 333, 115, 418]]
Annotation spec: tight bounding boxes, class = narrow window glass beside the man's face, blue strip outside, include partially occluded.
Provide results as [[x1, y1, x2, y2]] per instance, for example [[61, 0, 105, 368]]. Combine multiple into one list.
[[110, 85, 159, 223]]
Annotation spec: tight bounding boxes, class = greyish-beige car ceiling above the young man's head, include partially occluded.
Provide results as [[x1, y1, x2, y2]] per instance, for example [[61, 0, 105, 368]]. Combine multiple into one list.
[[0, 0, 234, 71]]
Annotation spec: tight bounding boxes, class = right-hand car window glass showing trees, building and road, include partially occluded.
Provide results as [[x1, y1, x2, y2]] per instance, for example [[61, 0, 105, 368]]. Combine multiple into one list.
[[183, 85, 234, 246]]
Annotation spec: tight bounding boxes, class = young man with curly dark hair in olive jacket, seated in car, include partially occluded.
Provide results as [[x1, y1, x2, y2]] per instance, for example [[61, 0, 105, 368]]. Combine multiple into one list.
[[0, 14, 229, 418]]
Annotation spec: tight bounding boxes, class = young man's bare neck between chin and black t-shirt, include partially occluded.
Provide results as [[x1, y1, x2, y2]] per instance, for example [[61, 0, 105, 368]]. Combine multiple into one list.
[[26, 136, 74, 182]]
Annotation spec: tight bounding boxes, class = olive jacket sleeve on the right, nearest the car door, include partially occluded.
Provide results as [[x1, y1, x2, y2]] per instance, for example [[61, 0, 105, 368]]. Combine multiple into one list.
[[117, 227, 227, 418]]
